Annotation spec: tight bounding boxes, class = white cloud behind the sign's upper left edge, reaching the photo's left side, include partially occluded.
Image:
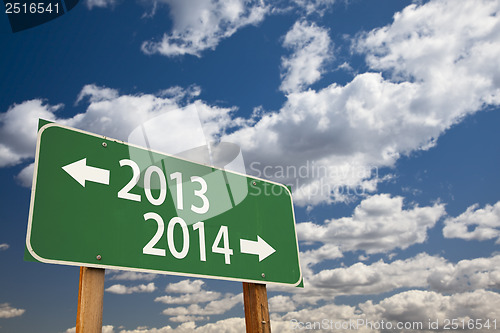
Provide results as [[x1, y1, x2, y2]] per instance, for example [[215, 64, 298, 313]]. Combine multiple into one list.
[[0, 85, 240, 187]]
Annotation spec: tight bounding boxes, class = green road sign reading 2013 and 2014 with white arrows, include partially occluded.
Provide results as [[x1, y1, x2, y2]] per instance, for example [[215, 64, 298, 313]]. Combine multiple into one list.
[[26, 123, 302, 285]]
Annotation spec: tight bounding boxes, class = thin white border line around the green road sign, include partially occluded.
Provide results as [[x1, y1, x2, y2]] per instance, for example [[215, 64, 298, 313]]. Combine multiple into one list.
[[26, 123, 302, 286]]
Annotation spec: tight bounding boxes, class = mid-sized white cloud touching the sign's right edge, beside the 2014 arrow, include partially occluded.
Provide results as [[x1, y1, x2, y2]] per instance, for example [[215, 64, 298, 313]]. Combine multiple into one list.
[[297, 194, 445, 254]]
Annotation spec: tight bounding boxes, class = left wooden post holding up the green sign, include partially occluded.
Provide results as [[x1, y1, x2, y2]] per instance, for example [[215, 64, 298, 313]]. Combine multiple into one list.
[[76, 267, 104, 333]]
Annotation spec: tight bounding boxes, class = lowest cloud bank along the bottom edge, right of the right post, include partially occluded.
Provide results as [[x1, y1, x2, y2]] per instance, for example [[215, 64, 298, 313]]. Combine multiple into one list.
[[271, 290, 500, 333]]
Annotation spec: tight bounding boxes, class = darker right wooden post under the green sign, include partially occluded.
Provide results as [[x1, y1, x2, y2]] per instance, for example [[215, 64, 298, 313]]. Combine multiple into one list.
[[243, 282, 271, 333]]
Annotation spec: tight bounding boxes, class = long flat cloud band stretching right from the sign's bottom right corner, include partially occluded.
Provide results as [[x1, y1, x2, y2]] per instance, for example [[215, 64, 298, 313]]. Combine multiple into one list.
[[284, 253, 500, 305]]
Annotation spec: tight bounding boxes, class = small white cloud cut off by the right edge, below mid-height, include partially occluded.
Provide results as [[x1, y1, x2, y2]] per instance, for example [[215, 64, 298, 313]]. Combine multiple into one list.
[[443, 201, 500, 244]]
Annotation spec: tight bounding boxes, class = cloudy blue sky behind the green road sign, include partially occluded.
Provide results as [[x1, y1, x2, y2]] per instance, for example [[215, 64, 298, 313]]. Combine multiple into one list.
[[0, 0, 500, 333]]
